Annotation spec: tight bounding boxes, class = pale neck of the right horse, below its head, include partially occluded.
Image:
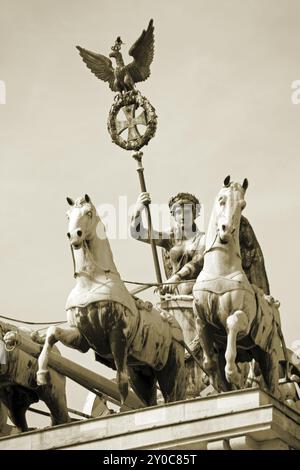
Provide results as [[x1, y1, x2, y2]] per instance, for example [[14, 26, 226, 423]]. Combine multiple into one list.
[[203, 211, 243, 276]]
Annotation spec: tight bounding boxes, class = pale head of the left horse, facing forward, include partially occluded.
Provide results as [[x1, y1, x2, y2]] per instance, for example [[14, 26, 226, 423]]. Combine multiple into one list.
[[67, 194, 99, 250]]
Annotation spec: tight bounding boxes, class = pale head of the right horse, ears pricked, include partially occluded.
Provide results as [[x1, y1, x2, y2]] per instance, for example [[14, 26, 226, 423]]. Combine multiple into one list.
[[215, 176, 248, 243]]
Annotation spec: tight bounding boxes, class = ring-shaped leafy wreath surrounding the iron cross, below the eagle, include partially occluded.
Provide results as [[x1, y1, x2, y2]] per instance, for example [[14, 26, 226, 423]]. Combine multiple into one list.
[[107, 90, 157, 151]]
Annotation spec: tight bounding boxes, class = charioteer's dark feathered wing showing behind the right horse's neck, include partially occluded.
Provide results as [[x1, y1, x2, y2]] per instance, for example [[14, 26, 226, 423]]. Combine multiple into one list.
[[240, 216, 270, 295]]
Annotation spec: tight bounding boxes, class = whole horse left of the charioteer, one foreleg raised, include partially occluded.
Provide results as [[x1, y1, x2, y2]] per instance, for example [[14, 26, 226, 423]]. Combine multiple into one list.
[[37, 195, 186, 405]]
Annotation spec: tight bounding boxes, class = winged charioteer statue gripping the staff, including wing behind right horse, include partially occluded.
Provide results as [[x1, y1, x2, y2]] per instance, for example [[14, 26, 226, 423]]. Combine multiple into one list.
[[131, 189, 269, 397]]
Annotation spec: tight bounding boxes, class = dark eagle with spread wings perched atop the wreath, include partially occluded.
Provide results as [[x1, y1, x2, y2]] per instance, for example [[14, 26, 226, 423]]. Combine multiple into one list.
[[76, 20, 154, 93]]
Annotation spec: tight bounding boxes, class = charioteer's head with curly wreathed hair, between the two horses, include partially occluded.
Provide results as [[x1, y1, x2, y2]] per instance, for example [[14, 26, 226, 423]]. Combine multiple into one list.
[[169, 193, 201, 228]]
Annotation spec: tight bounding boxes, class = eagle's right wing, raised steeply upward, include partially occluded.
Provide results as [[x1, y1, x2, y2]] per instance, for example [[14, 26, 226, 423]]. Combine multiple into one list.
[[126, 20, 154, 82]]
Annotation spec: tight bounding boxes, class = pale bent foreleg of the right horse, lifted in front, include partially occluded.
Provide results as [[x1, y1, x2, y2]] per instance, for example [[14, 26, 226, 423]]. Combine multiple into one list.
[[225, 310, 249, 385]]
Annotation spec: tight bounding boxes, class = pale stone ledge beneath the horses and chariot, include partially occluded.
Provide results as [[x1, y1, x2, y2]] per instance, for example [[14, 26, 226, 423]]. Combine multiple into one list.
[[0, 389, 300, 450]]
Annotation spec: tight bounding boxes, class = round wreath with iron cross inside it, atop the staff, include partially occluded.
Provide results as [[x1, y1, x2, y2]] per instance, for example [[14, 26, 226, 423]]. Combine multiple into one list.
[[107, 90, 157, 151]]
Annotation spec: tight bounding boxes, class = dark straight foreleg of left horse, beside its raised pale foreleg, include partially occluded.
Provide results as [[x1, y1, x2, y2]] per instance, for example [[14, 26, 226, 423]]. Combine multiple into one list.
[[109, 328, 129, 405]]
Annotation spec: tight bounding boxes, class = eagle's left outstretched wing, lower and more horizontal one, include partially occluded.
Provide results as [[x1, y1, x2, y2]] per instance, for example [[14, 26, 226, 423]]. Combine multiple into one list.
[[76, 46, 116, 91]]
